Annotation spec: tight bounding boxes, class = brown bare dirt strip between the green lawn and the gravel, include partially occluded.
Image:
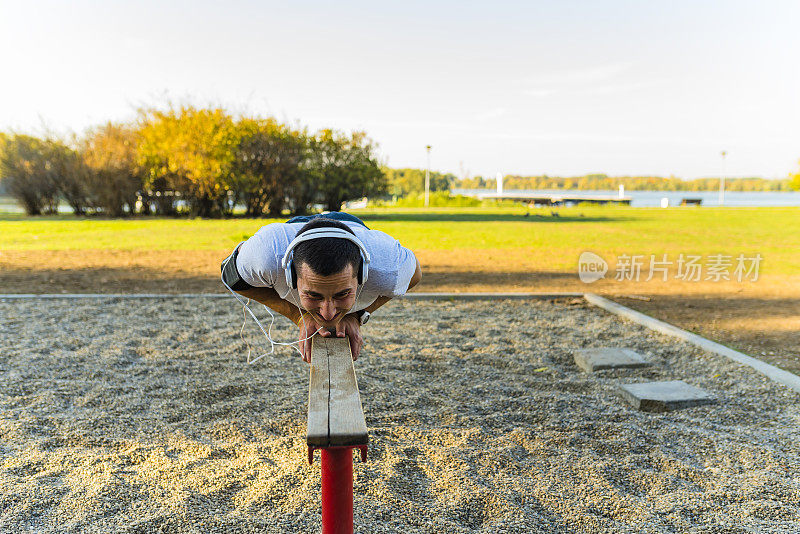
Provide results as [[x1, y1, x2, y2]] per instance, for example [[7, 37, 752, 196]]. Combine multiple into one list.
[[0, 250, 800, 373]]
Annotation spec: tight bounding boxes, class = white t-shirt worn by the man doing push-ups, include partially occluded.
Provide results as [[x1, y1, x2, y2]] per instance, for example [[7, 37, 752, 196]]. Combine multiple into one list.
[[236, 221, 417, 311]]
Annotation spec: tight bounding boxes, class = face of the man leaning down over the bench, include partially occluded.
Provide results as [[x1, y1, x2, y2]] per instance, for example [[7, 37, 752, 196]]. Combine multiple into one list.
[[297, 263, 358, 328]]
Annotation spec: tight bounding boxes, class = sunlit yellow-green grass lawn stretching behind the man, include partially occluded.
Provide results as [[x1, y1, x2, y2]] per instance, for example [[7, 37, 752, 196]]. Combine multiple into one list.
[[0, 206, 800, 275]]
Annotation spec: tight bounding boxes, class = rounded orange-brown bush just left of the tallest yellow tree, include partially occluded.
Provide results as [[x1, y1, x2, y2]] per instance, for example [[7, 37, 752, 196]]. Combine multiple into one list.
[[81, 122, 145, 217]]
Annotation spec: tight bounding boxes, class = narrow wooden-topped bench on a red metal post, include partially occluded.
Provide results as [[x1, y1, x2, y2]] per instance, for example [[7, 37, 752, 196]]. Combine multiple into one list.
[[306, 336, 368, 534]]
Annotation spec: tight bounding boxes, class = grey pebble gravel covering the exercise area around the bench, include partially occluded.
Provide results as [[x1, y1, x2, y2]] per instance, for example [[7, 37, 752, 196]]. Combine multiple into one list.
[[0, 298, 800, 533]]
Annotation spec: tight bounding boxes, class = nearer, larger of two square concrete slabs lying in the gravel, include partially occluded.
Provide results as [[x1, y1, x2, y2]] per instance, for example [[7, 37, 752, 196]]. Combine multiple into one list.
[[620, 380, 716, 412]]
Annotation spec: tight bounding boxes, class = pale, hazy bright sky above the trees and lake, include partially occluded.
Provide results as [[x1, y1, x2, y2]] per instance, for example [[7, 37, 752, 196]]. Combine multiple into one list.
[[0, 0, 800, 178]]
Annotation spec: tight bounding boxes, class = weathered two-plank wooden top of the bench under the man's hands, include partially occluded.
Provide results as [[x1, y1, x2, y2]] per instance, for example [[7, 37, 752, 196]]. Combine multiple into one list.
[[306, 336, 368, 447]]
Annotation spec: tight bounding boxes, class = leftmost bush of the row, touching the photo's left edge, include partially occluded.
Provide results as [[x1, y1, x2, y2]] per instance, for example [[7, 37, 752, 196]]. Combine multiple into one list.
[[0, 135, 58, 215]]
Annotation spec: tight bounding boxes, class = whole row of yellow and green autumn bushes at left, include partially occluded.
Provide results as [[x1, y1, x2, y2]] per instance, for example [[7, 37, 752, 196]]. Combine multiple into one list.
[[0, 107, 387, 217]]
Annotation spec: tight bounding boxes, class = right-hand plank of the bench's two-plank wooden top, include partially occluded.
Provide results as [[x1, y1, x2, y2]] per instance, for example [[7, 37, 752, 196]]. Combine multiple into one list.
[[326, 337, 367, 445]]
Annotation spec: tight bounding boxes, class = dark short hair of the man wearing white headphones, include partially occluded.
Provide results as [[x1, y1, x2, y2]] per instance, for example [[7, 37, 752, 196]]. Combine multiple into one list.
[[292, 217, 361, 282]]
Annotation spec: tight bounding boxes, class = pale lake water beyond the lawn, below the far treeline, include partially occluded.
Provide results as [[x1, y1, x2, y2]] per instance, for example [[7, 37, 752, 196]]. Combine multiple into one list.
[[452, 189, 800, 208]]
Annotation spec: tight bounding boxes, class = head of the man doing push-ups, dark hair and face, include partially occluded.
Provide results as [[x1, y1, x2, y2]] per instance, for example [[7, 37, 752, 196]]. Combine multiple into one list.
[[292, 218, 361, 327]]
